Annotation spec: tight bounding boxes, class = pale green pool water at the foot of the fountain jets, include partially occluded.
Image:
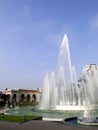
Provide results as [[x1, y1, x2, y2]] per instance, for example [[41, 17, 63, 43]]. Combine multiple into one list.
[[6, 106, 83, 119]]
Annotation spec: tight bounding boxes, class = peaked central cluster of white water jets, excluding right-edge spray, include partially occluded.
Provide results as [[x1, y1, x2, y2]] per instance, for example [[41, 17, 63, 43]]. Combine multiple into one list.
[[41, 34, 79, 109]]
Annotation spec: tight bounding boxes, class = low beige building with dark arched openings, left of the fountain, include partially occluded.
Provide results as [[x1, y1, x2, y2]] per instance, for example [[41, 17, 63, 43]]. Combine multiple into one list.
[[5, 88, 41, 103]]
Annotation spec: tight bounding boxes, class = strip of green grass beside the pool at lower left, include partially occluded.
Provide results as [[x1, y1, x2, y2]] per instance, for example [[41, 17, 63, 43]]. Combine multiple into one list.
[[0, 114, 40, 123]]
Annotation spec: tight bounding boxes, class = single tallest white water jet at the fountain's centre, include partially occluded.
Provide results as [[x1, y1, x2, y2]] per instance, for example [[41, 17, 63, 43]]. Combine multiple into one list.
[[57, 34, 74, 105]]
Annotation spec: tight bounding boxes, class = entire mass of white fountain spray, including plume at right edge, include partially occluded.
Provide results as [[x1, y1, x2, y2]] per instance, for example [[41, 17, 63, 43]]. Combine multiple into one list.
[[39, 34, 98, 109]]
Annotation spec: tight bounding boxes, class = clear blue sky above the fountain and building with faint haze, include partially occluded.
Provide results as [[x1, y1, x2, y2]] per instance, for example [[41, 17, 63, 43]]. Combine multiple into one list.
[[0, 0, 98, 90]]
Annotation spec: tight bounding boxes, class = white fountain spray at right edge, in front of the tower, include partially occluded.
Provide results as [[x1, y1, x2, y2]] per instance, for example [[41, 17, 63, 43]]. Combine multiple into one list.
[[81, 64, 98, 105]]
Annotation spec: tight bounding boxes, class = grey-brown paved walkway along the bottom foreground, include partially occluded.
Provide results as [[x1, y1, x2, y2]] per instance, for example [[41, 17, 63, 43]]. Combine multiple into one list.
[[0, 120, 98, 130]]
